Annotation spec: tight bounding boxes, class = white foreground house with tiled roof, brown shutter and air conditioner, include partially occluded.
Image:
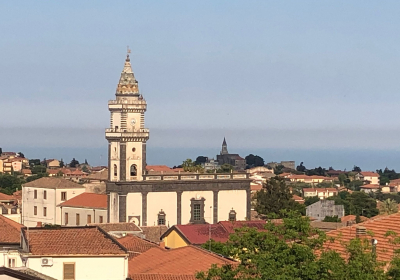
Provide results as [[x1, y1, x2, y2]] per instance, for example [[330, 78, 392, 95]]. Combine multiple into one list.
[[21, 226, 128, 280]]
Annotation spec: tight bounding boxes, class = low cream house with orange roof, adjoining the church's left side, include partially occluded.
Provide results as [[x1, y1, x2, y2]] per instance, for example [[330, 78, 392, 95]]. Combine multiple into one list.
[[57, 192, 107, 226]]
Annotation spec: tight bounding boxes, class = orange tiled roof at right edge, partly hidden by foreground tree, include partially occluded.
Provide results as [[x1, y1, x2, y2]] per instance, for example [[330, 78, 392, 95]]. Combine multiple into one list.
[[325, 213, 400, 261]]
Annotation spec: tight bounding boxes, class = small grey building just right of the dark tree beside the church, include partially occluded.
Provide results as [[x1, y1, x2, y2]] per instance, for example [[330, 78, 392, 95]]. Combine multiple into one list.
[[306, 200, 344, 221]]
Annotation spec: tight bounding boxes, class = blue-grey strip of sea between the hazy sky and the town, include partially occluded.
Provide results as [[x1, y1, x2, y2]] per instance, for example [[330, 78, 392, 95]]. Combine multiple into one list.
[[3, 146, 400, 172]]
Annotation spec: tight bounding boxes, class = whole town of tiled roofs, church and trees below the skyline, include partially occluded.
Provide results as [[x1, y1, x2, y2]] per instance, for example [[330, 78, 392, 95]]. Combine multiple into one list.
[[0, 53, 400, 280]]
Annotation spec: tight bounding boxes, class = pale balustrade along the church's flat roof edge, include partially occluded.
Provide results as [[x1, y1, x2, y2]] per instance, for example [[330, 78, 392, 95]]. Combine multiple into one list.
[[143, 173, 249, 181]]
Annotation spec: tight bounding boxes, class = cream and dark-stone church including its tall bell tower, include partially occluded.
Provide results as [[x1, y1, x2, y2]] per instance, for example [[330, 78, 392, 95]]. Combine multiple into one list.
[[105, 53, 251, 226]]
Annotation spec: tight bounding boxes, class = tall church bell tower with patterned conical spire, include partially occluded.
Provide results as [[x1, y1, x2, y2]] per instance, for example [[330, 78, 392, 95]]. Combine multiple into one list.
[[106, 49, 149, 182]]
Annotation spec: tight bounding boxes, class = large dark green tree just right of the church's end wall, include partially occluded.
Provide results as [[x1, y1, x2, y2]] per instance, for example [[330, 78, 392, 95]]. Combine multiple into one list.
[[255, 176, 305, 216]]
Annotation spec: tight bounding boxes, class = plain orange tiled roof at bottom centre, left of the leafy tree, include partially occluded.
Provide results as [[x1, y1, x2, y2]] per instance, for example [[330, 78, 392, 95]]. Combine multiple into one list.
[[128, 246, 236, 275]]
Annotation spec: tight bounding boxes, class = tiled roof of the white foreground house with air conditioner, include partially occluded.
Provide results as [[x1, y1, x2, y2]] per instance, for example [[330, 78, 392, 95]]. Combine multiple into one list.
[[22, 226, 127, 256]]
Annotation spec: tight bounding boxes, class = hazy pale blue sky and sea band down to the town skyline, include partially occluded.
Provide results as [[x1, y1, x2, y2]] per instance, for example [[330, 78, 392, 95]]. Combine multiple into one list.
[[0, 0, 400, 170]]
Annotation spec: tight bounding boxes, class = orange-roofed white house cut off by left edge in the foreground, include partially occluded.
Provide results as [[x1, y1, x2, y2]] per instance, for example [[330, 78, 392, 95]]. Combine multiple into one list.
[[0, 215, 23, 270]]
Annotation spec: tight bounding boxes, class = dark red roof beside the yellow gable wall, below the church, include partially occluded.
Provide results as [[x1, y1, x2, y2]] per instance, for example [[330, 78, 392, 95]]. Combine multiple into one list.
[[162, 220, 266, 245]]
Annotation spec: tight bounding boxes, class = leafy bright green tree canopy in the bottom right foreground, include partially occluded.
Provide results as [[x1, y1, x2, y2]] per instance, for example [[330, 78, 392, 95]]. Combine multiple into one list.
[[196, 211, 400, 280]]
